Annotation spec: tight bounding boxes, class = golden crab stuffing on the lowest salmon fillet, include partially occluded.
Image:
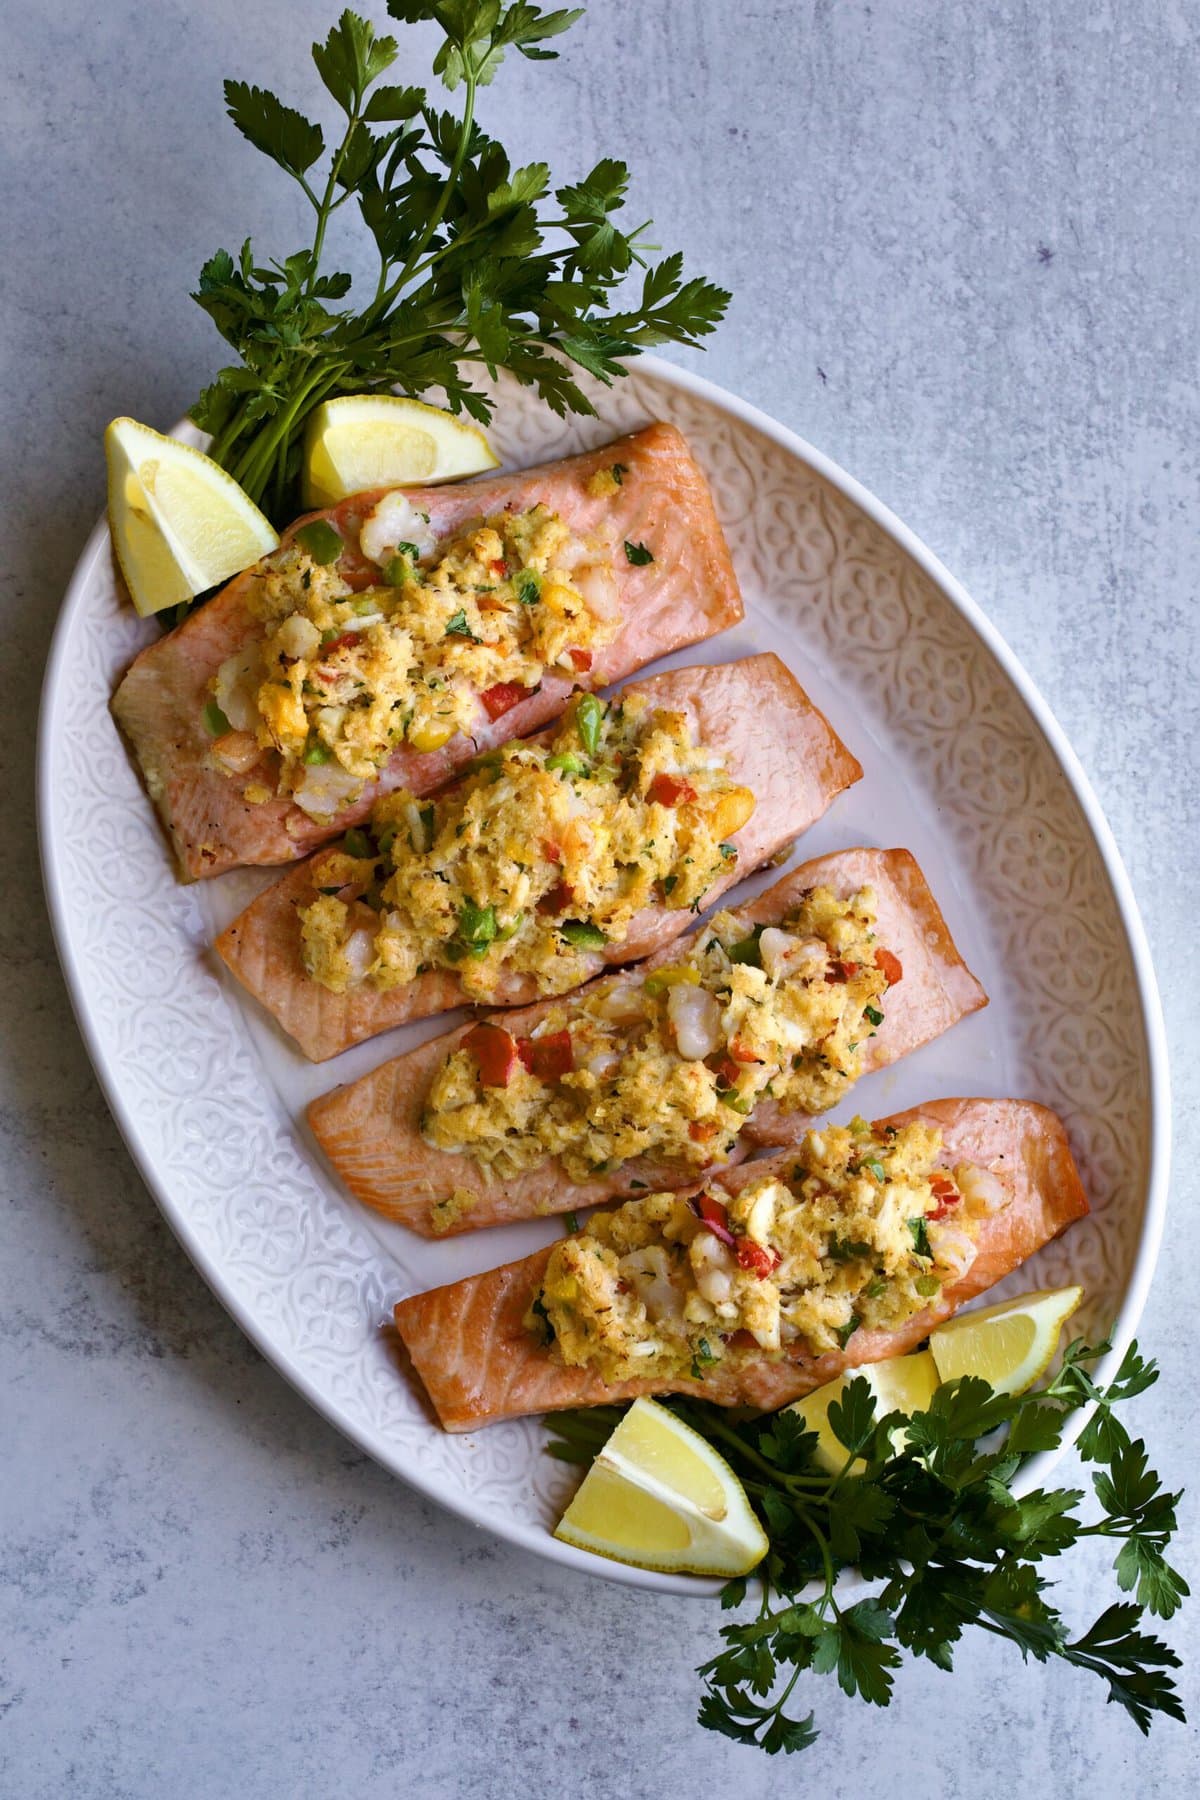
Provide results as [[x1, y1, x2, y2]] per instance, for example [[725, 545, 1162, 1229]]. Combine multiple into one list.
[[525, 1120, 1007, 1382]]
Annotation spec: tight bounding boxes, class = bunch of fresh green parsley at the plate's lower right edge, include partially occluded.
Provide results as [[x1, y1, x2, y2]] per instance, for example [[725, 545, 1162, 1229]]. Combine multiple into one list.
[[549, 1339, 1187, 1753]]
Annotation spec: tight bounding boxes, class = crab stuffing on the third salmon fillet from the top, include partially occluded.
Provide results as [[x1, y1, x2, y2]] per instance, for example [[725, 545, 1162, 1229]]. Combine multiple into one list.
[[423, 887, 903, 1181]]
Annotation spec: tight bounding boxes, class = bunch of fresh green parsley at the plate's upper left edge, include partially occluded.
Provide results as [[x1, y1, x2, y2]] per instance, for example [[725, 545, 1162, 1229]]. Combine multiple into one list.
[[191, 0, 729, 522]]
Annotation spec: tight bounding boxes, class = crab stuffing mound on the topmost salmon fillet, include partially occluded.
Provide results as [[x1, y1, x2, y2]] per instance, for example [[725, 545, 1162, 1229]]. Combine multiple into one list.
[[204, 495, 619, 817]]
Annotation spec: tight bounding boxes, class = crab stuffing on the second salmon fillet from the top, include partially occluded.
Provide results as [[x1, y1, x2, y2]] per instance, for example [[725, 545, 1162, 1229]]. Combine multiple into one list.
[[300, 693, 754, 1000]]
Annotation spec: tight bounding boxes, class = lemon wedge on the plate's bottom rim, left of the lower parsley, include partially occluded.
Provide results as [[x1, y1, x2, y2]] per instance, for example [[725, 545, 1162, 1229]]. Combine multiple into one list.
[[554, 1400, 768, 1575]]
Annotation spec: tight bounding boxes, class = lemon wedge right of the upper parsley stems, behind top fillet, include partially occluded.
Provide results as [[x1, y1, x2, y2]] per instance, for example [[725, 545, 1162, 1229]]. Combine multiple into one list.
[[302, 394, 500, 506]]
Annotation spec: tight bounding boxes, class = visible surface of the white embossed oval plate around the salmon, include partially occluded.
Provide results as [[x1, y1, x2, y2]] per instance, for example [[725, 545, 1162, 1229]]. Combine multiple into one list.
[[40, 356, 1168, 1593]]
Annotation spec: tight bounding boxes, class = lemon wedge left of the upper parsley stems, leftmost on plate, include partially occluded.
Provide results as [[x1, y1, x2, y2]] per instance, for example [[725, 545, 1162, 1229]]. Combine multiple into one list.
[[104, 419, 279, 614]]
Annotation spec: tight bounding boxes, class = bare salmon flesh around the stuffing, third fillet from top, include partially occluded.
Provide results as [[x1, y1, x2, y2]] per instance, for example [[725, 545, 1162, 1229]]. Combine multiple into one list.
[[308, 850, 988, 1237]]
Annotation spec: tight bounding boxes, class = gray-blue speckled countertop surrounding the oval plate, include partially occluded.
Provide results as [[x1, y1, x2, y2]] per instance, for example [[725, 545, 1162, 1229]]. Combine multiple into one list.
[[0, 0, 1200, 1800]]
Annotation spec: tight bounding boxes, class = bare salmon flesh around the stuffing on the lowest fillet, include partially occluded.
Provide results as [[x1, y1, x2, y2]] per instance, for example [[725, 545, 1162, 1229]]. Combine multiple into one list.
[[396, 1100, 1088, 1431]]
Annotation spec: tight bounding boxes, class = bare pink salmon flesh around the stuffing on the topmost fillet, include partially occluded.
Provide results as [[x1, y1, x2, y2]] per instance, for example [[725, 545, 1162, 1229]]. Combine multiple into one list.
[[112, 425, 743, 880]]
